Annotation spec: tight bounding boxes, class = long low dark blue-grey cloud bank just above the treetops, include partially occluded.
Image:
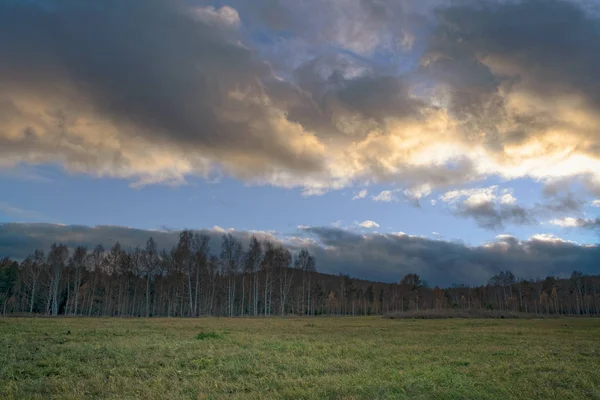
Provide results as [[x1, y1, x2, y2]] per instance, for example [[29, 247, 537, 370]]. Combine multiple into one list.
[[0, 224, 600, 285]]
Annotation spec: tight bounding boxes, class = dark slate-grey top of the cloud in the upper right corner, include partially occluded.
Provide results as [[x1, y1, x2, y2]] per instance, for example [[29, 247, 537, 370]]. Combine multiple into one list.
[[439, 0, 600, 101]]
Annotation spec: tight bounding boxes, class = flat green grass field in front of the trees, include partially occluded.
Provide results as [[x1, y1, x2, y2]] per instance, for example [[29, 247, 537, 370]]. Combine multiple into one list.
[[0, 317, 600, 399]]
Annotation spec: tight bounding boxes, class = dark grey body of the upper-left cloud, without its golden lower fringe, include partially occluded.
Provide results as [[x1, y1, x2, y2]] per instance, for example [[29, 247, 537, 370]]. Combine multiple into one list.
[[0, 0, 320, 180]]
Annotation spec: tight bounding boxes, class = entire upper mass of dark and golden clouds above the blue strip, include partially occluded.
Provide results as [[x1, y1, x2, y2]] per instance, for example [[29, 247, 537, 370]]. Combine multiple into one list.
[[0, 0, 600, 203]]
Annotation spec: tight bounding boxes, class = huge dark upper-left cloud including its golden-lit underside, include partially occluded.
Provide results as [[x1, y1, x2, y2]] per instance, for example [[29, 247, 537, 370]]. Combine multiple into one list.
[[0, 0, 324, 190]]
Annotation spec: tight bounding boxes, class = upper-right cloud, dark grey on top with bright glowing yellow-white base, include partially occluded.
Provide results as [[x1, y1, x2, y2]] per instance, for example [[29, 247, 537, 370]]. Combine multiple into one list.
[[422, 0, 600, 189]]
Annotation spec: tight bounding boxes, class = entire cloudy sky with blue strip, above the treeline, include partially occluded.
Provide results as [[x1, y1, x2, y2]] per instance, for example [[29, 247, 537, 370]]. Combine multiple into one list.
[[0, 0, 600, 284]]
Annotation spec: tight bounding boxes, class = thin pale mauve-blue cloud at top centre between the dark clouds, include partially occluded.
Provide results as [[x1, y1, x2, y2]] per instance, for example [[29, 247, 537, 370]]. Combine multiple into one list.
[[229, 0, 417, 58]]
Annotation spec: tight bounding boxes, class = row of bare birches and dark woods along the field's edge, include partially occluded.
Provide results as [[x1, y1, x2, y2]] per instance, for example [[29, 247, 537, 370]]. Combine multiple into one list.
[[0, 231, 600, 317]]
